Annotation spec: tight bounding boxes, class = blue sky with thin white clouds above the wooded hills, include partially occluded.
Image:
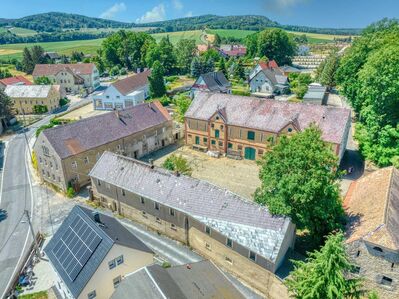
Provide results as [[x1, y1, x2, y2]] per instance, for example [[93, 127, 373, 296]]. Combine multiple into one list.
[[0, 0, 399, 28]]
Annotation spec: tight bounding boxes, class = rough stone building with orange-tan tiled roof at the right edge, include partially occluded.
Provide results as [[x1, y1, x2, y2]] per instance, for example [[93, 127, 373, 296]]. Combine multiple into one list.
[[344, 167, 399, 299]]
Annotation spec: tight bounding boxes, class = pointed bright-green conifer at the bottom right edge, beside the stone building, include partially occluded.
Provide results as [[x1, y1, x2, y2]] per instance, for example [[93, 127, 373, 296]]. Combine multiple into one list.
[[286, 232, 365, 299]]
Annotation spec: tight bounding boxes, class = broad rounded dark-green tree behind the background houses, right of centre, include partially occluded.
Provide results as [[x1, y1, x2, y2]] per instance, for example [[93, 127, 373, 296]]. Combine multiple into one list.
[[257, 28, 296, 65]]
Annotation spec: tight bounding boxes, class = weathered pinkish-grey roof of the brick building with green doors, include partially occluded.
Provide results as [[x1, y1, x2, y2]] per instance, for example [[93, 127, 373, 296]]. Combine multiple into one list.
[[185, 92, 351, 144]]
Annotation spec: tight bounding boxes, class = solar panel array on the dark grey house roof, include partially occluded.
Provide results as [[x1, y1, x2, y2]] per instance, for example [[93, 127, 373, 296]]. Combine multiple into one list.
[[52, 215, 102, 281]]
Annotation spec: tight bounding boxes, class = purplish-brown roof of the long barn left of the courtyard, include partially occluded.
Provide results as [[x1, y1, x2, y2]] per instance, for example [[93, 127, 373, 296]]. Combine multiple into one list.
[[43, 101, 171, 159]]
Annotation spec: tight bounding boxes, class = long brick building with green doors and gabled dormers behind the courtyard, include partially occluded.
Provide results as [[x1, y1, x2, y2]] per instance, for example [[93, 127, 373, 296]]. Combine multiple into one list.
[[184, 92, 351, 164]]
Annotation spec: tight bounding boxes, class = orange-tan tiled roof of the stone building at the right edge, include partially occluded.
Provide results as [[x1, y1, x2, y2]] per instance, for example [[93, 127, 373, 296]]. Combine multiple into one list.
[[344, 167, 399, 250]]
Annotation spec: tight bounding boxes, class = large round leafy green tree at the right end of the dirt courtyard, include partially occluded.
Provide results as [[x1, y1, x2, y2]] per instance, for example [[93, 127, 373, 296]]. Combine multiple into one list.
[[255, 125, 343, 244]]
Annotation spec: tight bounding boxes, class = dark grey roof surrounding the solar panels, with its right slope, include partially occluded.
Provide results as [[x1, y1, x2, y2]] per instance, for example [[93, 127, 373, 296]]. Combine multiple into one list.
[[44, 206, 152, 298]]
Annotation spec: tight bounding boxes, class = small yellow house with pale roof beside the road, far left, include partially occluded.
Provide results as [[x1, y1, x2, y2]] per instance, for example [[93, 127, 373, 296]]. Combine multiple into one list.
[[4, 85, 61, 114]]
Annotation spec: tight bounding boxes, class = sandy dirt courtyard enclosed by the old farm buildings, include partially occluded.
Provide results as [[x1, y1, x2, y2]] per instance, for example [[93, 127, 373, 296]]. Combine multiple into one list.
[[148, 146, 260, 199]]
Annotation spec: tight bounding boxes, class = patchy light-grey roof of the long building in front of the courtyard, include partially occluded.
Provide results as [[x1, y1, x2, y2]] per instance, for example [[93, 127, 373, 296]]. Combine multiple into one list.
[[89, 152, 290, 262]]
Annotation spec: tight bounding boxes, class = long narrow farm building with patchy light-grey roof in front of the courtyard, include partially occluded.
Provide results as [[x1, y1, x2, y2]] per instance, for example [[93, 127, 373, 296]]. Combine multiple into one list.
[[90, 152, 295, 299]]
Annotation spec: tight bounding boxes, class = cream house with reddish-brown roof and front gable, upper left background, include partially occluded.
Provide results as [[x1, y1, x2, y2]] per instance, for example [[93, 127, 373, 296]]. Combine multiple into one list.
[[33, 63, 100, 93]]
